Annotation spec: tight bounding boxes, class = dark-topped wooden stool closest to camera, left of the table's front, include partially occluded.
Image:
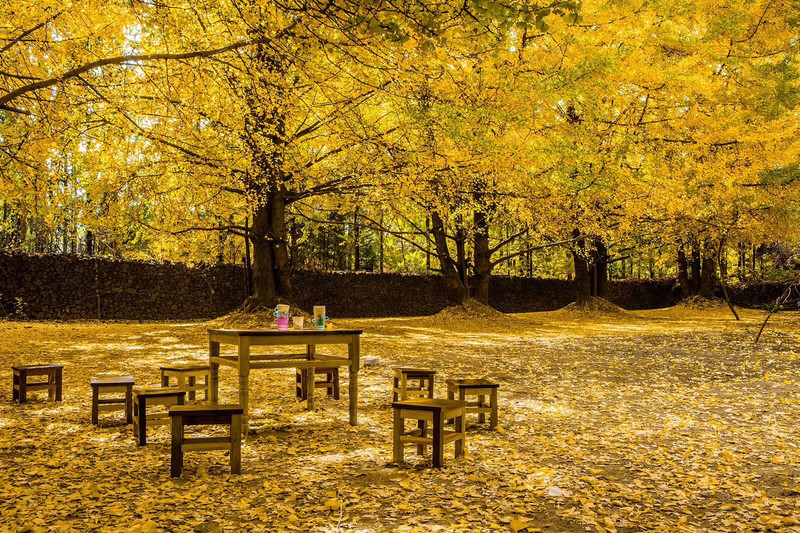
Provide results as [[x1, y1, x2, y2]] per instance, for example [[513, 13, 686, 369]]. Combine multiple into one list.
[[169, 404, 243, 477]]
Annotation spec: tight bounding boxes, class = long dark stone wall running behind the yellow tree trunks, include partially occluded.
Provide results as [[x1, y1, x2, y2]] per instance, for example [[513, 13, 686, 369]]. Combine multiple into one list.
[[0, 253, 783, 320]]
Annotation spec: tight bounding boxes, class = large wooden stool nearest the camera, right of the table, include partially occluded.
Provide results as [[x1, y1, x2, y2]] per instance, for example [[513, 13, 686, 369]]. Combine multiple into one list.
[[392, 398, 467, 468]]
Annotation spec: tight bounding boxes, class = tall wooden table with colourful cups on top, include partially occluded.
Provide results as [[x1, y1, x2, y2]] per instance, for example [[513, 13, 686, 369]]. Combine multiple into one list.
[[208, 329, 361, 431]]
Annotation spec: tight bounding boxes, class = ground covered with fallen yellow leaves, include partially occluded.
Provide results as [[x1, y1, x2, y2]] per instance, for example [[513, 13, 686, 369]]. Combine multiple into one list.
[[0, 308, 800, 533]]
